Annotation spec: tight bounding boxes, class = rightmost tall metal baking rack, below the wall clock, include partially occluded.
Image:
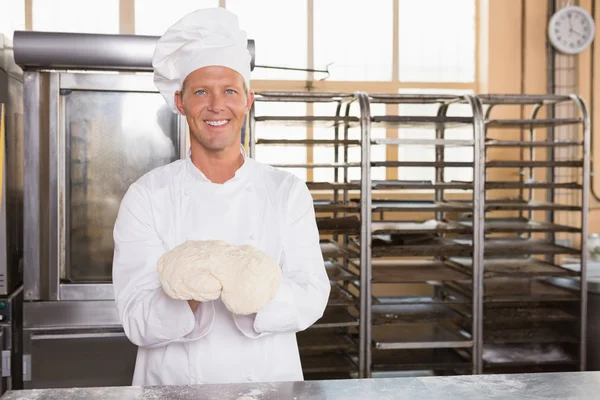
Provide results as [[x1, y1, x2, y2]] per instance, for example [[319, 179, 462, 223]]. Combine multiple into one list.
[[464, 95, 590, 372]]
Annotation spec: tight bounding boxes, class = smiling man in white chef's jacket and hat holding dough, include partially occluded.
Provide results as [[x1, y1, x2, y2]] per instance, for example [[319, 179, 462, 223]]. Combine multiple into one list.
[[113, 8, 330, 385]]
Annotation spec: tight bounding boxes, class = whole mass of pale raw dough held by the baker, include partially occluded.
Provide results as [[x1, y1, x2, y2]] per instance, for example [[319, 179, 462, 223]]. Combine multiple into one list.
[[158, 240, 282, 315]]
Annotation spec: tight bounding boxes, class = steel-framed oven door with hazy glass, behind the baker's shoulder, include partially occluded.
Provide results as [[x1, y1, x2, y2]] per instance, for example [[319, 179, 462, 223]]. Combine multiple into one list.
[[59, 74, 185, 300]]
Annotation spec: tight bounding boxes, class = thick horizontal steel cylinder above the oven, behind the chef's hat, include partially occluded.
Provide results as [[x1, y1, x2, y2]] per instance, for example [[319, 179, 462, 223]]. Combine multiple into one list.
[[13, 31, 256, 71]]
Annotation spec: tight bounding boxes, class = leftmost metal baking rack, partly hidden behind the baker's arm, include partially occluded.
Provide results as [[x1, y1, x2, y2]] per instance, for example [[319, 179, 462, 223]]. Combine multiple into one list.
[[248, 91, 365, 379]]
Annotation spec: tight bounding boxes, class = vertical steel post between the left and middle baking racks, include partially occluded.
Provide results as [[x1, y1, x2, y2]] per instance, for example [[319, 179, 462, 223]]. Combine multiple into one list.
[[355, 92, 372, 378]]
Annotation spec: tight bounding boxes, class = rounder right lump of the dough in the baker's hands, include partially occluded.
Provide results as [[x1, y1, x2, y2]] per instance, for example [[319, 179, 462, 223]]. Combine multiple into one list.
[[212, 245, 282, 315]]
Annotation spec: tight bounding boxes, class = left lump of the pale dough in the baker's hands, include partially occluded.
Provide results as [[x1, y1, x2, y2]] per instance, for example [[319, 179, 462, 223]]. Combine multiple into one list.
[[157, 241, 222, 301]]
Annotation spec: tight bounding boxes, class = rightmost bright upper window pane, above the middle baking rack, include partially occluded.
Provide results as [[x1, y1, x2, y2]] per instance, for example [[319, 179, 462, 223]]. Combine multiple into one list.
[[398, 0, 475, 82]]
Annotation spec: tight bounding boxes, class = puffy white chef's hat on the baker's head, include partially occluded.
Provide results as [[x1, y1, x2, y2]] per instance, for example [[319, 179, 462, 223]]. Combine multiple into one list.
[[152, 7, 252, 113]]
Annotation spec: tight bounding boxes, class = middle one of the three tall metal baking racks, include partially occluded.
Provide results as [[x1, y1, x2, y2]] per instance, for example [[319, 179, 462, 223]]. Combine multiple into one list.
[[351, 94, 483, 376]]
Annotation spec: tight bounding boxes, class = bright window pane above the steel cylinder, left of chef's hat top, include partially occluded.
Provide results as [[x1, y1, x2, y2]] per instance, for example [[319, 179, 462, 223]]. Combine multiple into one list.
[[134, 0, 219, 36]]
